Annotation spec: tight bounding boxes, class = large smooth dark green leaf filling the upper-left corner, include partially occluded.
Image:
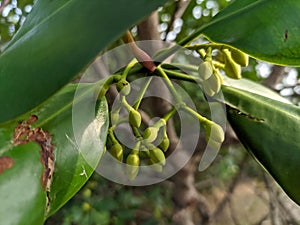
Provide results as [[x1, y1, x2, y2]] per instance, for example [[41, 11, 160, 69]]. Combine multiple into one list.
[[0, 0, 166, 123]]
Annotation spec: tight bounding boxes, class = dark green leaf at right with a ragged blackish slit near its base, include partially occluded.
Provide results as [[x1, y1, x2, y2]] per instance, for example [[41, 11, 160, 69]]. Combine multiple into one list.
[[222, 81, 300, 204]]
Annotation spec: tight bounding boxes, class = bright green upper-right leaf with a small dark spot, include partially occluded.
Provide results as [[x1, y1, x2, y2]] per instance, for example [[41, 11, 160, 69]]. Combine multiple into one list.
[[202, 0, 300, 66]]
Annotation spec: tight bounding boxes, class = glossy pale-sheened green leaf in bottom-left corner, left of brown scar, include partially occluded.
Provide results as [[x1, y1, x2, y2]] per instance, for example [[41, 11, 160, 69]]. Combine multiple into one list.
[[0, 143, 46, 225]]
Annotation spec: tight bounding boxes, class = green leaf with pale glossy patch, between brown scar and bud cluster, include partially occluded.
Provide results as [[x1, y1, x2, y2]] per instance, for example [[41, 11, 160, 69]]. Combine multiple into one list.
[[36, 81, 108, 215]]
